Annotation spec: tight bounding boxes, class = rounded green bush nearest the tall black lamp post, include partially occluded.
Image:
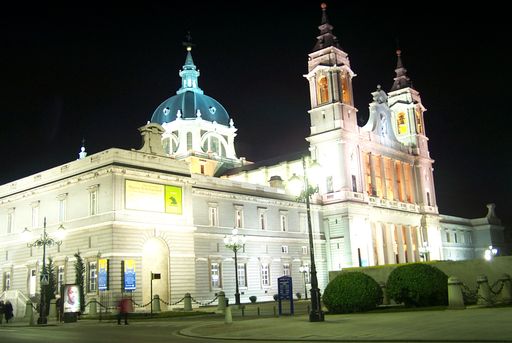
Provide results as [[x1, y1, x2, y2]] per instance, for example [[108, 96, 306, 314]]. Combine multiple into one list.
[[322, 272, 382, 313]]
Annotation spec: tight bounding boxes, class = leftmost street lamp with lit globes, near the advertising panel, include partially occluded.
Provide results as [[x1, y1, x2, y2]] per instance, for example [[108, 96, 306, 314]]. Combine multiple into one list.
[[21, 217, 66, 324]]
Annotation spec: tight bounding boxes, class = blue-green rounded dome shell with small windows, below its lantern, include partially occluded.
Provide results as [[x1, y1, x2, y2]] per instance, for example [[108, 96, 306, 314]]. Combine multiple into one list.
[[151, 90, 229, 126]]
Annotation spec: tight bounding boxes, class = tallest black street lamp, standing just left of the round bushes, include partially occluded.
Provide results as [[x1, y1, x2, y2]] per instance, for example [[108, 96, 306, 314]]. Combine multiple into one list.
[[289, 157, 324, 322]]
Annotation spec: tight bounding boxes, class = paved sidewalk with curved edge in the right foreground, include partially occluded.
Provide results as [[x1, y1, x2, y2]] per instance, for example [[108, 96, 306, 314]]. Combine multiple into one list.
[[180, 307, 512, 342]]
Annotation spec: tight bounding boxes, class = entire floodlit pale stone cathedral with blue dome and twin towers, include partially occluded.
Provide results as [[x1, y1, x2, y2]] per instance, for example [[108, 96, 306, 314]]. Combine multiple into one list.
[[0, 6, 504, 313]]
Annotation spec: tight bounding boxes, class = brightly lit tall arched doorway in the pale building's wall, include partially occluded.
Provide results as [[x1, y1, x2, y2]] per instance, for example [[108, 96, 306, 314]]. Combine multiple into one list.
[[142, 238, 169, 304]]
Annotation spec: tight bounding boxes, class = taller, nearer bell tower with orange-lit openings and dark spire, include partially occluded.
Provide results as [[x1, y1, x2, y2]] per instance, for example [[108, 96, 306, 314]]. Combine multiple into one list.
[[304, 3, 359, 194]]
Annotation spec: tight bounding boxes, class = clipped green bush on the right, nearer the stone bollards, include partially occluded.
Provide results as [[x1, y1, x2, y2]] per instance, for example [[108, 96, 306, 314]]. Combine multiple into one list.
[[386, 263, 448, 307]]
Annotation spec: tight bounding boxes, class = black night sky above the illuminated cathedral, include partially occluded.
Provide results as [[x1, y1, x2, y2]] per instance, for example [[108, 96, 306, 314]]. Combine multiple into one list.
[[0, 0, 512, 226]]
